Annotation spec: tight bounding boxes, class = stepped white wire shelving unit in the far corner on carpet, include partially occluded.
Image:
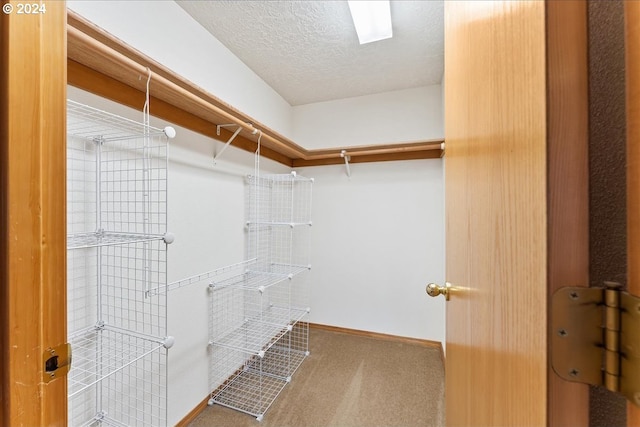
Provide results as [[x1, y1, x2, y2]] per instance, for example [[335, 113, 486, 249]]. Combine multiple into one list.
[[209, 172, 313, 421]]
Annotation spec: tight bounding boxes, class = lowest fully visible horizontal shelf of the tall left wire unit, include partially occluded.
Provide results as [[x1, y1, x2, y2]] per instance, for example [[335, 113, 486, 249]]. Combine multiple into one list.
[[67, 328, 164, 398]]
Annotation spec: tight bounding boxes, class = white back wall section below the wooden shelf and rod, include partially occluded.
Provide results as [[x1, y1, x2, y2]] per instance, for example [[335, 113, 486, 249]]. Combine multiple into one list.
[[299, 159, 445, 343]]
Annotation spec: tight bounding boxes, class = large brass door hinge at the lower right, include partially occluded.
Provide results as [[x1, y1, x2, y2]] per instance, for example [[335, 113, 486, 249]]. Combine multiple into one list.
[[551, 282, 640, 406]]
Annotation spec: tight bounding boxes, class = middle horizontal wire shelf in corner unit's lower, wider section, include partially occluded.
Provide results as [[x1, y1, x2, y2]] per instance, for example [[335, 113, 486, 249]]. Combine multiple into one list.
[[211, 307, 309, 354]]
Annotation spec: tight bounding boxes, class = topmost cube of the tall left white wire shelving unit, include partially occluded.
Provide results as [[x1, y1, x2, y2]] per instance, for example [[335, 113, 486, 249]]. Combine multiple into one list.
[[67, 101, 168, 241]]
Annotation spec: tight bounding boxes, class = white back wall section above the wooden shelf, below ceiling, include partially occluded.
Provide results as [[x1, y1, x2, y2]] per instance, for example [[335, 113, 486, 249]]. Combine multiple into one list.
[[293, 85, 444, 149]]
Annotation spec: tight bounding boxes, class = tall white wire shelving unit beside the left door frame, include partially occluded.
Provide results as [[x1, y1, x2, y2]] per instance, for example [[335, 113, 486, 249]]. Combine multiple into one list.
[[67, 100, 173, 426]]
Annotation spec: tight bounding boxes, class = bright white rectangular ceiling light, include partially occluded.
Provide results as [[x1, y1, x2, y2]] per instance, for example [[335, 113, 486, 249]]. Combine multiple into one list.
[[347, 0, 393, 44]]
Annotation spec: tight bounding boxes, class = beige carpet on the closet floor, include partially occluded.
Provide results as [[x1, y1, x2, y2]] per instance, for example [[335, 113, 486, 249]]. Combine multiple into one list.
[[190, 328, 444, 427]]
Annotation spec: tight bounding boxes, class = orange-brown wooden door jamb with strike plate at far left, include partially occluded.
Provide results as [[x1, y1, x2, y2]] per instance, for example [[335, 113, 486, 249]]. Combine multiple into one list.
[[0, 1, 67, 426]]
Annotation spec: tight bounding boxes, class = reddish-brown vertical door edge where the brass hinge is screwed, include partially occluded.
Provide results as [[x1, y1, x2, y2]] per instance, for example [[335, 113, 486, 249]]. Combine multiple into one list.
[[546, 0, 589, 426]]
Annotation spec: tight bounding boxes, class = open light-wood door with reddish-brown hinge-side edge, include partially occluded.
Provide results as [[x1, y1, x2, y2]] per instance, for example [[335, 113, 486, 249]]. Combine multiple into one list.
[[444, 1, 588, 426]]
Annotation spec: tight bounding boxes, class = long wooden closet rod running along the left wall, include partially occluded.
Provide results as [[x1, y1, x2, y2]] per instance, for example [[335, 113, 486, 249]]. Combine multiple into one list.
[[67, 26, 303, 158]]
